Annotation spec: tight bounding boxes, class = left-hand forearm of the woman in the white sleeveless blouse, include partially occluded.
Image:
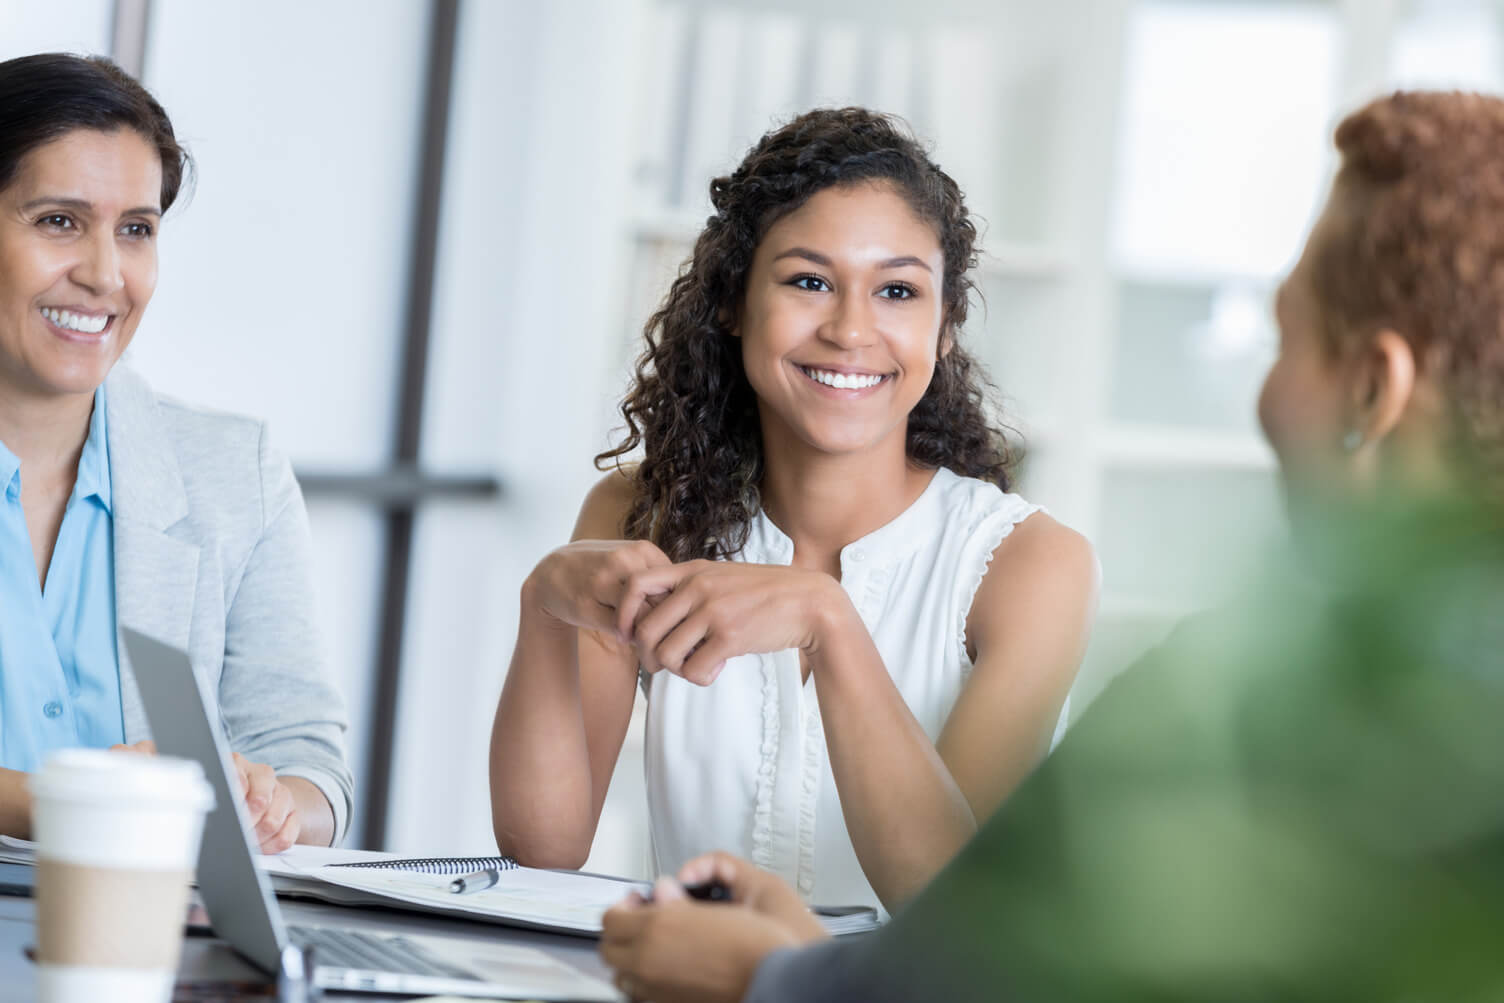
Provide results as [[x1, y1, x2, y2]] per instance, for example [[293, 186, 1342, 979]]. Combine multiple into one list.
[[490, 585, 596, 868]]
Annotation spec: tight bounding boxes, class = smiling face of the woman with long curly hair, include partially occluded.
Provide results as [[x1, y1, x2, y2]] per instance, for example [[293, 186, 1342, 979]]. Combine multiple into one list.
[[735, 185, 949, 456]]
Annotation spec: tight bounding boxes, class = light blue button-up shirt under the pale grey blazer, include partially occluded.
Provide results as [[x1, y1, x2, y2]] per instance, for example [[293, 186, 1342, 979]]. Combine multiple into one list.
[[0, 386, 125, 771]]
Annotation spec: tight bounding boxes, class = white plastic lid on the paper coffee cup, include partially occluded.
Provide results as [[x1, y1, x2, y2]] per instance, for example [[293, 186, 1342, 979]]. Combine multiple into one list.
[[29, 749, 214, 812]]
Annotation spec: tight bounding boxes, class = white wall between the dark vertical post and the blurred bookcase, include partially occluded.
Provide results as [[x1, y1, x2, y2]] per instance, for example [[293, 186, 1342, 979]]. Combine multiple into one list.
[[391, 0, 638, 863]]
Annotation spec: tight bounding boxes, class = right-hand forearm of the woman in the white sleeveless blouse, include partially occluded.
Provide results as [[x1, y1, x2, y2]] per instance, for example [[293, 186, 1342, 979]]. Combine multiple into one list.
[[809, 592, 978, 911]]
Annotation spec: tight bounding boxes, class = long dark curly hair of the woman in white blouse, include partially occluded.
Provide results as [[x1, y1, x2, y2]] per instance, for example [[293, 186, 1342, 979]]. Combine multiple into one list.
[[596, 108, 1012, 561]]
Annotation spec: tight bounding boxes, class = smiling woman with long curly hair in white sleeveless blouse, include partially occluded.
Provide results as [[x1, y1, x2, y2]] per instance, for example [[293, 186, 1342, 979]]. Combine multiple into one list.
[[490, 108, 1096, 907]]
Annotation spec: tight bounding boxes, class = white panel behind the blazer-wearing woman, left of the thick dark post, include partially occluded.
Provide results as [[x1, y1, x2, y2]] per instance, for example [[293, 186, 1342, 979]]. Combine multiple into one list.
[[131, 0, 427, 848]]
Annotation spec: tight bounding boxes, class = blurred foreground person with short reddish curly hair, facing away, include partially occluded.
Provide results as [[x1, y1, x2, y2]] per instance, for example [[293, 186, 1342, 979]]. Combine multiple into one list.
[[602, 93, 1504, 1003]]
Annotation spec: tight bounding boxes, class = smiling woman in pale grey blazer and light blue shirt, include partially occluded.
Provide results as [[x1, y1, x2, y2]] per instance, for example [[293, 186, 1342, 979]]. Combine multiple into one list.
[[0, 54, 352, 853]]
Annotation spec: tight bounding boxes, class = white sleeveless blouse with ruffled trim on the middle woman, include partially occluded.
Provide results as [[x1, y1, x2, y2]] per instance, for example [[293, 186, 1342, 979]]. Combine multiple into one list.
[[644, 469, 1066, 908]]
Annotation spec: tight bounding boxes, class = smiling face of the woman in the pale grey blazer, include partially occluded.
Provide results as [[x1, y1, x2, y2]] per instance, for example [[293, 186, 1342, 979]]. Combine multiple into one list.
[[0, 129, 162, 397]]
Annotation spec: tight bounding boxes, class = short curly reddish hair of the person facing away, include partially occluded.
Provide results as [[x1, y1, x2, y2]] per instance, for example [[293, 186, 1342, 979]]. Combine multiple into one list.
[[1314, 92, 1504, 496]]
